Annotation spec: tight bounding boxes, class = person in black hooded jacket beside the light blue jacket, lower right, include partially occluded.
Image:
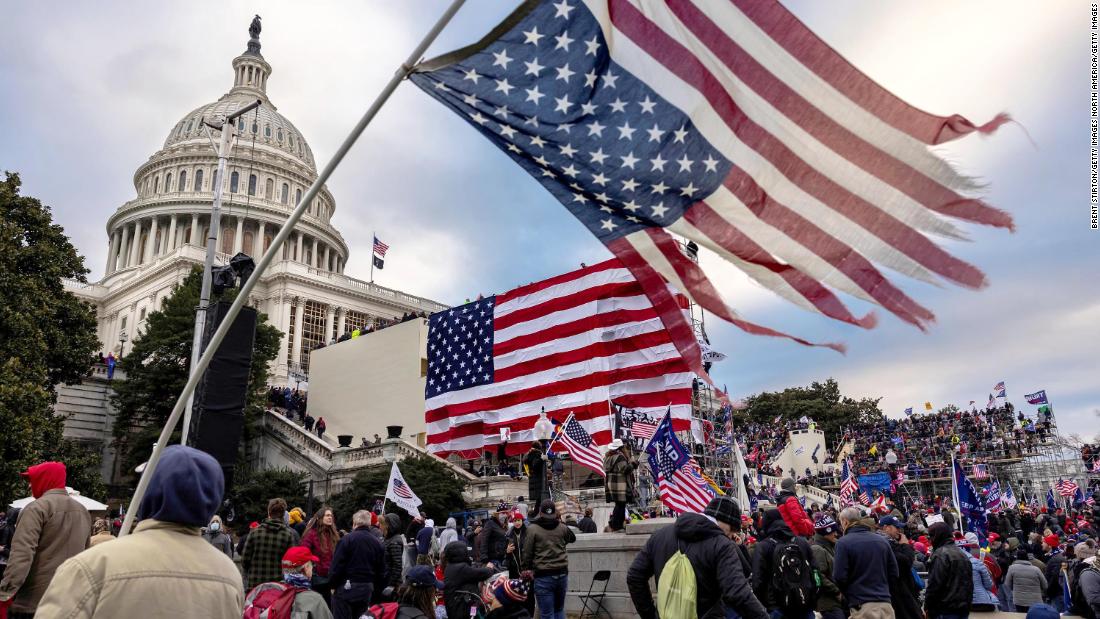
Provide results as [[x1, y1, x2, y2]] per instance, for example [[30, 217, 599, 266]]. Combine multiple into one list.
[[924, 522, 974, 619]]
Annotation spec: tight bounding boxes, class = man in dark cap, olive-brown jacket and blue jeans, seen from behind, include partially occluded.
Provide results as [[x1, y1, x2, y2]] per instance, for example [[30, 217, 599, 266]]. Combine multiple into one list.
[[520, 499, 576, 619]]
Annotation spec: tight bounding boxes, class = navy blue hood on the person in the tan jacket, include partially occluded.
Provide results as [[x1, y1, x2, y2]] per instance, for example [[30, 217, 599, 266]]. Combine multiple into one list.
[[138, 445, 226, 527]]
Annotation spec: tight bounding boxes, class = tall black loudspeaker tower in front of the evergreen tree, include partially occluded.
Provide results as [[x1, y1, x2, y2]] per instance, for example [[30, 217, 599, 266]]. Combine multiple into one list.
[[190, 301, 256, 493]]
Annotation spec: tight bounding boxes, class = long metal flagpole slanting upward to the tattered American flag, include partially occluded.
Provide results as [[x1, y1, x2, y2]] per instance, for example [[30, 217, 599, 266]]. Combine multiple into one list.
[[119, 0, 465, 537]]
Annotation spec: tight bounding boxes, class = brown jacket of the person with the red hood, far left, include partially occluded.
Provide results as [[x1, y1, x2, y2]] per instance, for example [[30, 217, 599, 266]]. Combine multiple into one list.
[[0, 488, 91, 614]]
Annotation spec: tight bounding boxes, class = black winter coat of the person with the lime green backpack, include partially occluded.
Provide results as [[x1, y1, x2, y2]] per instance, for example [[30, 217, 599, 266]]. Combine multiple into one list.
[[626, 513, 768, 619]]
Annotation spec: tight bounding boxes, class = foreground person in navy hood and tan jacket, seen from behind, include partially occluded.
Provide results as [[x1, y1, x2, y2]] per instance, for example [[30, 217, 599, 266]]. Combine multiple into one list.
[[37, 445, 245, 619]]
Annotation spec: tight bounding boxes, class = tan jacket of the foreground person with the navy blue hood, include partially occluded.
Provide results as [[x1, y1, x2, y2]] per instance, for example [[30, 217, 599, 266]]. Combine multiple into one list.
[[39, 520, 244, 619]]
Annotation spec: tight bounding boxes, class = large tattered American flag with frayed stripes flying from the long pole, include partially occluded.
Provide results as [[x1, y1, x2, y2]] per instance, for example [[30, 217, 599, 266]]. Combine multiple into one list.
[[410, 0, 1012, 371]]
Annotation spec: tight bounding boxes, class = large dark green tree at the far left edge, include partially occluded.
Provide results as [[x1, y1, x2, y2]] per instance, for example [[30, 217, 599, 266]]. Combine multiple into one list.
[[0, 173, 102, 505]]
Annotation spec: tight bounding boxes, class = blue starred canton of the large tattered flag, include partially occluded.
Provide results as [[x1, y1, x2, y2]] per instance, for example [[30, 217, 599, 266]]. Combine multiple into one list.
[[413, 0, 730, 242]]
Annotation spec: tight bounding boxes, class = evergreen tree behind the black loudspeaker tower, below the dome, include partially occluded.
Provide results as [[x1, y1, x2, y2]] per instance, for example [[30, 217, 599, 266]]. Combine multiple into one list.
[[112, 268, 281, 481]]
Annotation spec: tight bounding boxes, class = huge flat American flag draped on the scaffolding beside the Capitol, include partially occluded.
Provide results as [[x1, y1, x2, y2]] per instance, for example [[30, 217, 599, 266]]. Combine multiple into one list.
[[425, 258, 693, 457]]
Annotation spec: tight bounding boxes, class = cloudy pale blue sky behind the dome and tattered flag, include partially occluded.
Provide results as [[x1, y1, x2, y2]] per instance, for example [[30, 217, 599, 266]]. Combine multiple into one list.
[[0, 0, 1100, 435]]
